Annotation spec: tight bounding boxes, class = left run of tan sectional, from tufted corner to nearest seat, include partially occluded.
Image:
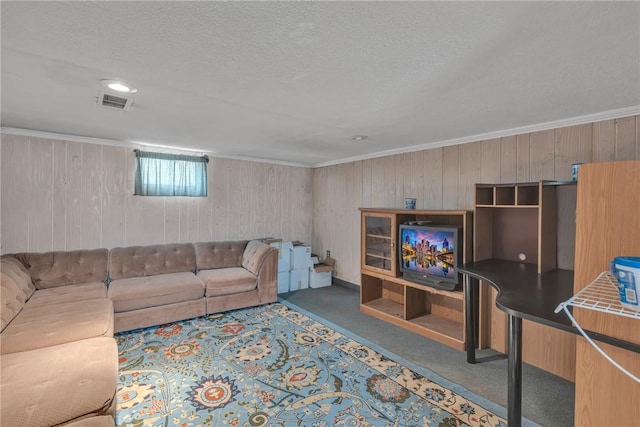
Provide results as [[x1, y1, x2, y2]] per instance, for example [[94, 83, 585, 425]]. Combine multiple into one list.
[[0, 254, 118, 426]]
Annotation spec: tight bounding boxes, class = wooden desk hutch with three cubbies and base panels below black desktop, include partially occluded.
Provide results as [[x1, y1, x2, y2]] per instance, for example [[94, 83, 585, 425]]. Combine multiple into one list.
[[473, 181, 576, 380]]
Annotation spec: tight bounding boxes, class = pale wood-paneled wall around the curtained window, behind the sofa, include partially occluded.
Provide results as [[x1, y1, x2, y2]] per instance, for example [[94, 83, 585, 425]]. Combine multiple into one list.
[[0, 134, 313, 253]]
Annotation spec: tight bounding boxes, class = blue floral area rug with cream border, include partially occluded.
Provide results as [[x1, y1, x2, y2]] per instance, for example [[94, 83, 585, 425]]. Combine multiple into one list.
[[116, 303, 506, 427]]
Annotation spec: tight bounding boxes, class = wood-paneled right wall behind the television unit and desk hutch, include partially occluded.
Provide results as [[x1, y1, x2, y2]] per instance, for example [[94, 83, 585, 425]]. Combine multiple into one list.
[[313, 116, 640, 284]]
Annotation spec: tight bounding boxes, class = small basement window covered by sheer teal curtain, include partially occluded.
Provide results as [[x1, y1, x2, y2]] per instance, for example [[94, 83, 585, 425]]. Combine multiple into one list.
[[133, 150, 209, 197]]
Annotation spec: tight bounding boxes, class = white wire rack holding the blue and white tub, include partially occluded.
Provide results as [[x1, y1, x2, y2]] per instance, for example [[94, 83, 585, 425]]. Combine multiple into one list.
[[556, 271, 640, 319]]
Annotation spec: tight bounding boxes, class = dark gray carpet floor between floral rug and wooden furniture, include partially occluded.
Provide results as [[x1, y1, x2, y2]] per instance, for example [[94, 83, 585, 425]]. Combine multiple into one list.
[[278, 284, 575, 427]]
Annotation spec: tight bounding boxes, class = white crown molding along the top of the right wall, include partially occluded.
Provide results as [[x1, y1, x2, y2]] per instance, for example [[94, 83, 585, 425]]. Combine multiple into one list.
[[312, 105, 640, 168]]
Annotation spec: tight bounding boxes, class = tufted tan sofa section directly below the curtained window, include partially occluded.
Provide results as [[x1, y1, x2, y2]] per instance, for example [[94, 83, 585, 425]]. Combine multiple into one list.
[[108, 243, 206, 332]]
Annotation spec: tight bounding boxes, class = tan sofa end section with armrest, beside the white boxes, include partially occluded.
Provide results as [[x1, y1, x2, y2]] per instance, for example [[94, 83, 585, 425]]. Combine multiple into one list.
[[195, 240, 278, 314]]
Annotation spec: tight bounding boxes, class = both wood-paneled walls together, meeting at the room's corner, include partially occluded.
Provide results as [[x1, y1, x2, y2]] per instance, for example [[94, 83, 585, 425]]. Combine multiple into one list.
[[0, 116, 640, 266]]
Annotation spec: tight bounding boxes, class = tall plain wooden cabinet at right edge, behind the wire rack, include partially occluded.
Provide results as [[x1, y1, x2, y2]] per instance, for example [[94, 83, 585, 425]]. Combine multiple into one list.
[[574, 160, 640, 426]]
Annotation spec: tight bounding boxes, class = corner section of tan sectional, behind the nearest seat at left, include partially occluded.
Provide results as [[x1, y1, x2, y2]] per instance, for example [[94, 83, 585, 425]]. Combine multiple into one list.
[[0, 249, 113, 354]]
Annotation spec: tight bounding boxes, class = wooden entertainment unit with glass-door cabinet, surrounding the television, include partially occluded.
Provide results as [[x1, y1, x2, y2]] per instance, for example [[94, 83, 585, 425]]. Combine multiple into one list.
[[360, 208, 473, 350]]
